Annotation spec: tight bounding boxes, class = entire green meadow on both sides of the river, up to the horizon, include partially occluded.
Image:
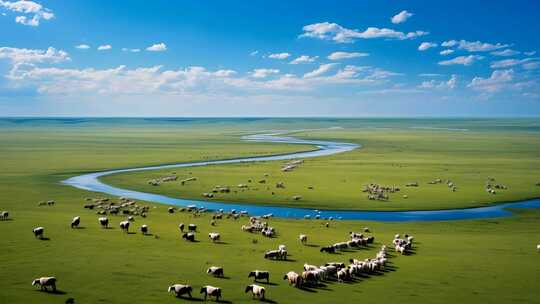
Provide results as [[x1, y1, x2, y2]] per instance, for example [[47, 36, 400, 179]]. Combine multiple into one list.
[[0, 119, 540, 304]]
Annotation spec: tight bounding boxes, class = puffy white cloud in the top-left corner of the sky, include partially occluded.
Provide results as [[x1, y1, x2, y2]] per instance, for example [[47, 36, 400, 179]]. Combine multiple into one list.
[[0, 0, 54, 26]]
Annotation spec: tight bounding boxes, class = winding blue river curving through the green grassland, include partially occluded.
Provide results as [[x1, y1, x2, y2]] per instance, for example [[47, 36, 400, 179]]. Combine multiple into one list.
[[62, 131, 540, 222]]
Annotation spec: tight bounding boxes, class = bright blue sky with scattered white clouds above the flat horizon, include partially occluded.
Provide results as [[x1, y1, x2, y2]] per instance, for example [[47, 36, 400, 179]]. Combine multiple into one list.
[[0, 0, 540, 116]]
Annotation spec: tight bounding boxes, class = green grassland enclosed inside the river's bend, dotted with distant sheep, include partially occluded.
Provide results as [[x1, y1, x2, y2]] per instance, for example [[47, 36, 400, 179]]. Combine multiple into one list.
[[102, 128, 540, 210]]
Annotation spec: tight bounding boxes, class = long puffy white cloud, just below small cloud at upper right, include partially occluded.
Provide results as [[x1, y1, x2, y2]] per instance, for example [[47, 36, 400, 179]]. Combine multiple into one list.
[[300, 22, 429, 43]]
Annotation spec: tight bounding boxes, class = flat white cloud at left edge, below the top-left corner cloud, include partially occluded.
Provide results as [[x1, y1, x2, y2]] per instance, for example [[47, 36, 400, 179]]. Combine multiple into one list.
[[0, 47, 71, 65]]
